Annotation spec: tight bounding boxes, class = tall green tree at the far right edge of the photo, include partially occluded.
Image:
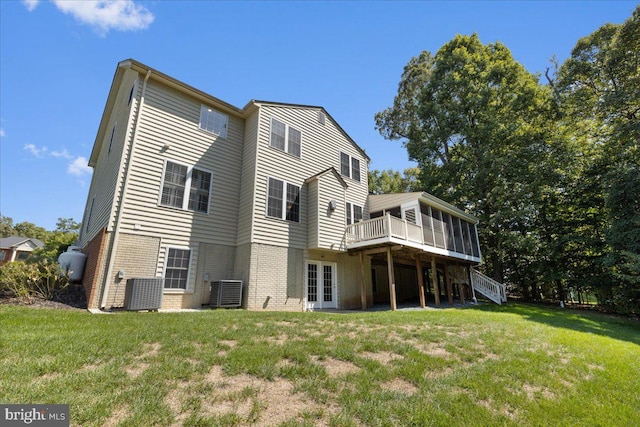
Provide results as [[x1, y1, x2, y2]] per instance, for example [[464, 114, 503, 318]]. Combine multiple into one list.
[[555, 6, 640, 313]]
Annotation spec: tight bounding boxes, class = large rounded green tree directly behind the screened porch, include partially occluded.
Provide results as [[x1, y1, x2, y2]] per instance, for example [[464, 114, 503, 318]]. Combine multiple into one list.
[[376, 34, 557, 293]]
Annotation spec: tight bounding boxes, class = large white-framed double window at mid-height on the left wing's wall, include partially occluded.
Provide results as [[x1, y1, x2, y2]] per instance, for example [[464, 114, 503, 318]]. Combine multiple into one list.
[[160, 161, 212, 213]]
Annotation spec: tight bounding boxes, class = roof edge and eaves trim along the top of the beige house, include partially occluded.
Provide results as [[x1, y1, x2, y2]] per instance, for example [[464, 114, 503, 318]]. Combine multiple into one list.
[[89, 59, 371, 167]]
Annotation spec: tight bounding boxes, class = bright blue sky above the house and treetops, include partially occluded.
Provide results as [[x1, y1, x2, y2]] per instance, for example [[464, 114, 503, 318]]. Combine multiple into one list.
[[0, 0, 637, 229]]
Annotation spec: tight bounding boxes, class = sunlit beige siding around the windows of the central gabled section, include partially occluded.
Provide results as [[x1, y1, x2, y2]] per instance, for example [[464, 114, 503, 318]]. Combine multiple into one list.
[[252, 104, 367, 248]]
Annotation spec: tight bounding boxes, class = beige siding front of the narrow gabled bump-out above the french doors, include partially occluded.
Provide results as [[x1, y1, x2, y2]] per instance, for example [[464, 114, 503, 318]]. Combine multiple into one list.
[[318, 173, 348, 250]]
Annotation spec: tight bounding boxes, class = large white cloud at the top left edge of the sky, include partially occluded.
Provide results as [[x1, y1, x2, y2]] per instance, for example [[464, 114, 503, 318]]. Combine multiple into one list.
[[51, 0, 155, 35]]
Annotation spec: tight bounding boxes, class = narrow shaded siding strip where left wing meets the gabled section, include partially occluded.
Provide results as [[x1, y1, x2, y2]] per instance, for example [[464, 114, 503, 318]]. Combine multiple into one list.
[[237, 111, 260, 246]]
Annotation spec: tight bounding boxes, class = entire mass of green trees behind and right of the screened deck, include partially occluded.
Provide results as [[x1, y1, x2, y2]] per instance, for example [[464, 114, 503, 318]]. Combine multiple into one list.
[[370, 6, 640, 314]]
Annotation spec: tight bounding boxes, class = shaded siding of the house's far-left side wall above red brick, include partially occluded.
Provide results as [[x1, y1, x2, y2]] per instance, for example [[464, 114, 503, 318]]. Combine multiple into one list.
[[79, 70, 142, 246]]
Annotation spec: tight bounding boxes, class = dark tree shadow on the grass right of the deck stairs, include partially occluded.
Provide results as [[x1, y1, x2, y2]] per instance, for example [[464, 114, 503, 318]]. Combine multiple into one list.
[[468, 303, 640, 345]]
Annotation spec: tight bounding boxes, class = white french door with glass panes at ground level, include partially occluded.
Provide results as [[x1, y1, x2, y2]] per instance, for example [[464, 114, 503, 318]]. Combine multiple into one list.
[[305, 261, 338, 310]]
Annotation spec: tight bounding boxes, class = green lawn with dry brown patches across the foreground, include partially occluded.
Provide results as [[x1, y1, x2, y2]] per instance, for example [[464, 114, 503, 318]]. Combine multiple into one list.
[[0, 304, 640, 426]]
